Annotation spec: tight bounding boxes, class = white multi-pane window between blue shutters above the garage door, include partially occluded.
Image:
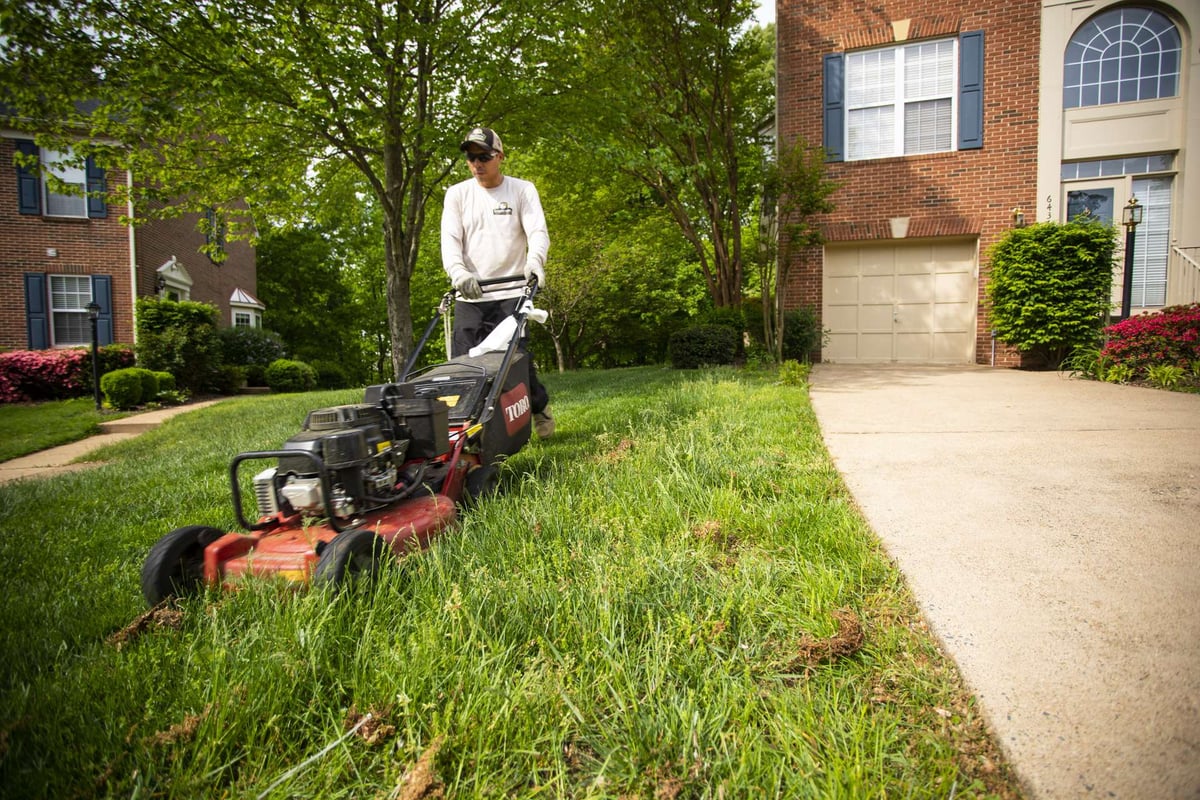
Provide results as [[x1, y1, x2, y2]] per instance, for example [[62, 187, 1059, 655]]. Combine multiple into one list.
[[846, 38, 958, 161]]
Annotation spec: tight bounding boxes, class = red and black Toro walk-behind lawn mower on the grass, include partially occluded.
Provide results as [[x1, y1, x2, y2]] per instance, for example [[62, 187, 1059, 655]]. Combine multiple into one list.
[[142, 278, 544, 606]]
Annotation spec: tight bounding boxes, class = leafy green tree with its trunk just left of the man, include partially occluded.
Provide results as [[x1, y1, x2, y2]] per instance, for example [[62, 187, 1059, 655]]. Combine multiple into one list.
[[0, 0, 568, 381]]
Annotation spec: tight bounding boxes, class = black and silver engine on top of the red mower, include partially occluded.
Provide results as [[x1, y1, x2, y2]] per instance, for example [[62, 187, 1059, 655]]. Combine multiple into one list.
[[254, 404, 409, 518]]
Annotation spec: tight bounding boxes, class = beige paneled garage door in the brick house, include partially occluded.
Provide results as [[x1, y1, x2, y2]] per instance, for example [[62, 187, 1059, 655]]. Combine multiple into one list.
[[822, 239, 978, 363]]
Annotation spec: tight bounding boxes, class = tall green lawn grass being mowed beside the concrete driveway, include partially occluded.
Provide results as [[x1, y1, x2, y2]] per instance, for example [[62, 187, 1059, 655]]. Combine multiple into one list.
[[0, 368, 1019, 799]]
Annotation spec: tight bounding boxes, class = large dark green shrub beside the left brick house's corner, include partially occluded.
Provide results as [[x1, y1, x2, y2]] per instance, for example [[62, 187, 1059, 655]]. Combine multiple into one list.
[[137, 297, 222, 393]]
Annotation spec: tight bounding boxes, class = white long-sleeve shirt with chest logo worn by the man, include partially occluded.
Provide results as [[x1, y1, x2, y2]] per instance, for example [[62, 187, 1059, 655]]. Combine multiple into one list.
[[442, 175, 550, 300]]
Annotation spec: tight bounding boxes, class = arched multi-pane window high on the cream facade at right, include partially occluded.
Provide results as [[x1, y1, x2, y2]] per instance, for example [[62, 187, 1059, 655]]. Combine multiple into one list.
[[1062, 7, 1181, 108]]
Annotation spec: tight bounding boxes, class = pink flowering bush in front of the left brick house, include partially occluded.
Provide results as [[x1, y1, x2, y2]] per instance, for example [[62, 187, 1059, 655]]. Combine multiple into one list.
[[0, 344, 133, 403]]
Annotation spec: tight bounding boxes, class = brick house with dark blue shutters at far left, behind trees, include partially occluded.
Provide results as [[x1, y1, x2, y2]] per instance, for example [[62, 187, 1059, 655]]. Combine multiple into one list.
[[0, 130, 264, 350]]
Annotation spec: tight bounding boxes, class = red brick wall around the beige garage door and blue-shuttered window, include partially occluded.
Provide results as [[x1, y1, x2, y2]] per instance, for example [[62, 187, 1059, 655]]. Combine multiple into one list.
[[775, 0, 1042, 366]]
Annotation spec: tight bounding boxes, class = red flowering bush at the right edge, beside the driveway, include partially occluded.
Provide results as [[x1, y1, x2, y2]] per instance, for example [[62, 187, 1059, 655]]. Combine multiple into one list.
[[1100, 303, 1200, 378]]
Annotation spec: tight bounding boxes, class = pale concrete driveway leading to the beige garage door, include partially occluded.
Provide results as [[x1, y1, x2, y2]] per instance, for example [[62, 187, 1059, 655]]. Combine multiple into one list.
[[811, 365, 1200, 800]]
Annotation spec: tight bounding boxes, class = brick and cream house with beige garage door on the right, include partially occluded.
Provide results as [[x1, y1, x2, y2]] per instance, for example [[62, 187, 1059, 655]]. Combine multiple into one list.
[[775, 0, 1200, 366]]
